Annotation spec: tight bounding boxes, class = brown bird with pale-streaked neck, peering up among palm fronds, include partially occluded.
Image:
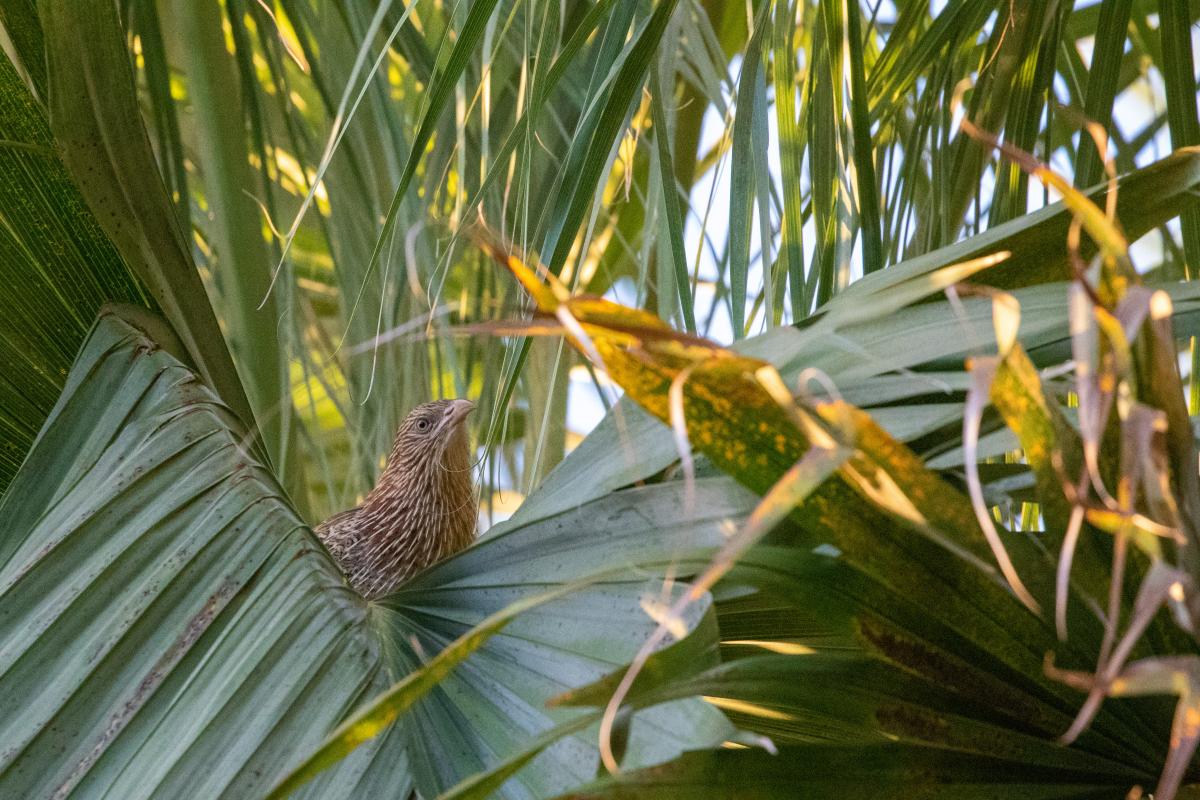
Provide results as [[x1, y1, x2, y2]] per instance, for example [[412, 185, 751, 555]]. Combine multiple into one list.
[[316, 399, 478, 600]]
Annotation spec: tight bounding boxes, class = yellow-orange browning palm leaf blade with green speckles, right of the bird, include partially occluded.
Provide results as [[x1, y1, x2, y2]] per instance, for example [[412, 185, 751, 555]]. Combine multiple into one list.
[[484, 239, 1051, 642]]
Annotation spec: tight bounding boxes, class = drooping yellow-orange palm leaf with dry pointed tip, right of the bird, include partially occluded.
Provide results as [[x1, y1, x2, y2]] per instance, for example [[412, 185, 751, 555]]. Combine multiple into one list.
[[496, 247, 1097, 692]]
